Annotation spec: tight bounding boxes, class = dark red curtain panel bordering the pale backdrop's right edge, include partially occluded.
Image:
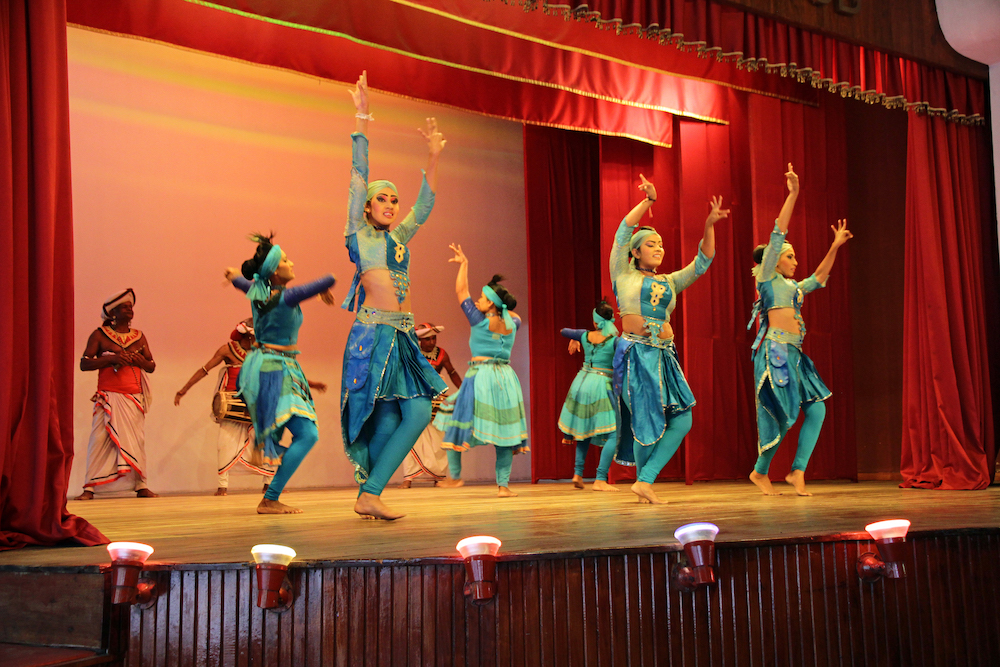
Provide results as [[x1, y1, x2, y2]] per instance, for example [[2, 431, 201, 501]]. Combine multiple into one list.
[[524, 125, 611, 482]]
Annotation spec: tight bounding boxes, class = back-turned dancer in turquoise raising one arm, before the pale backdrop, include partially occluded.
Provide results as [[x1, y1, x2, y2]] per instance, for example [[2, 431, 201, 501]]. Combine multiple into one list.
[[434, 243, 529, 498]]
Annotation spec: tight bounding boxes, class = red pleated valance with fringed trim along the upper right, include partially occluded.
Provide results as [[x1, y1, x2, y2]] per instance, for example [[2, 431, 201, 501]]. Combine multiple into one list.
[[506, 0, 986, 123]]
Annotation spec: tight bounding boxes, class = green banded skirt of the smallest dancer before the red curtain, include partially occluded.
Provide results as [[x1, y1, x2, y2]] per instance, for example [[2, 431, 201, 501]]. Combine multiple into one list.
[[559, 363, 618, 444]]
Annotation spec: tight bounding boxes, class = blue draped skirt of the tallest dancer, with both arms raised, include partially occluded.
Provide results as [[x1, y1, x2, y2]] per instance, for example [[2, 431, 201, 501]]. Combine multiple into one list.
[[340, 307, 448, 484]]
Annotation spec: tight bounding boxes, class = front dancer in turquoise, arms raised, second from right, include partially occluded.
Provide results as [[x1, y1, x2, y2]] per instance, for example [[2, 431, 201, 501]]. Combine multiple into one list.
[[611, 174, 729, 504]]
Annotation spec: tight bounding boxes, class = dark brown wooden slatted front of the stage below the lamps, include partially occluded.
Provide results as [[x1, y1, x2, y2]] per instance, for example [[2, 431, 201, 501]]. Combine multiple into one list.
[[120, 532, 1000, 667]]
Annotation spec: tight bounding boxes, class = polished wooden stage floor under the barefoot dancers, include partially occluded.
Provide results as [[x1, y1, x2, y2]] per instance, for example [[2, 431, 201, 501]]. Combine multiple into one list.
[[0, 482, 1000, 569]]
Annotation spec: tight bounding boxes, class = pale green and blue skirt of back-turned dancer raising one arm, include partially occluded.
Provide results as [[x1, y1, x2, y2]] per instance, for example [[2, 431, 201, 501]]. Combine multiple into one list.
[[434, 359, 529, 454]]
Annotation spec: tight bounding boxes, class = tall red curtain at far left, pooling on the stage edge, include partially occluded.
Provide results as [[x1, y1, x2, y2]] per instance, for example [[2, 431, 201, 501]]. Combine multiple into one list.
[[0, 0, 107, 550]]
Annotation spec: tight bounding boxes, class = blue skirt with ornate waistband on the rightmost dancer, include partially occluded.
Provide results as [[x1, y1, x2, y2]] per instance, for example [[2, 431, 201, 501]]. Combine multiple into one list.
[[753, 329, 833, 454]]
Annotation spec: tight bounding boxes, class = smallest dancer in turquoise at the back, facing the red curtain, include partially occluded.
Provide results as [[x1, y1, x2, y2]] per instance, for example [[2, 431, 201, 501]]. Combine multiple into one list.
[[559, 300, 618, 491]]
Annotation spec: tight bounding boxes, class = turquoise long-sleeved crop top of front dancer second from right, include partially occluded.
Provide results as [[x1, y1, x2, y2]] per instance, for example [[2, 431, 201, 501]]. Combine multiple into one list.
[[611, 219, 712, 322]]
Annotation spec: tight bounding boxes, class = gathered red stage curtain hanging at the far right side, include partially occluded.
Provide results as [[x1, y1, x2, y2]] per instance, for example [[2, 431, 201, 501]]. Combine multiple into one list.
[[901, 114, 996, 489]]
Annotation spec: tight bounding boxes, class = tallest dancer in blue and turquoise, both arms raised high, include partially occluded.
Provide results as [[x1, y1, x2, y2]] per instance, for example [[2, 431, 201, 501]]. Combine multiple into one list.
[[340, 73, 447, 520]]
